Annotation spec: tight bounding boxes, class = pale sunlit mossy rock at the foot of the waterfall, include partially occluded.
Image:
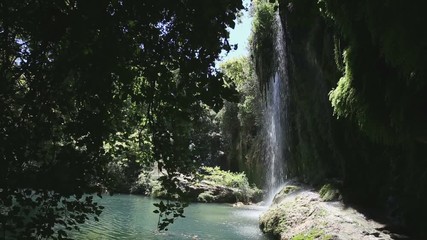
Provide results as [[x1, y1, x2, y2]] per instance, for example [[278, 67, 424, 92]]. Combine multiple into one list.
[[260, 185, 406, 240]]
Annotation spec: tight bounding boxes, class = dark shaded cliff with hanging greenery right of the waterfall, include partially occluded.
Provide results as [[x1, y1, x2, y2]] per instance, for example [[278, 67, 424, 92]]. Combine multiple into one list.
[[253, 0, 427, 236]]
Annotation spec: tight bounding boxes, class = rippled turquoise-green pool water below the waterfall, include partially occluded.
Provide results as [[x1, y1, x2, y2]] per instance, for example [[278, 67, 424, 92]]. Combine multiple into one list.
[[72, 195, 268, 240]]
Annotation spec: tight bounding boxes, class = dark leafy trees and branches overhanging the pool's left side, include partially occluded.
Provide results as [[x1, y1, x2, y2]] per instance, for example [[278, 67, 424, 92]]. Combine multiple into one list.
[[0, 0, 243, 238]]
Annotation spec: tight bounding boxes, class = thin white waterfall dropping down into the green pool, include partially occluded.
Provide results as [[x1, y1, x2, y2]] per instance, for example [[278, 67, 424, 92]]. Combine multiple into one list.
[[264, 13, 289, 203]]
